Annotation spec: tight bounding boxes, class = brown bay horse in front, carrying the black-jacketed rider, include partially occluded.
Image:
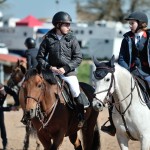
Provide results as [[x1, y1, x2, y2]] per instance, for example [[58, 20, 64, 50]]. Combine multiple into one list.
[[19, 69, 100, 150]]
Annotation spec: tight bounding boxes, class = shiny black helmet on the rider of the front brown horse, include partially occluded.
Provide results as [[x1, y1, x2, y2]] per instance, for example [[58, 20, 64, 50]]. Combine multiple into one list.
[[52, 11, 72, 27]]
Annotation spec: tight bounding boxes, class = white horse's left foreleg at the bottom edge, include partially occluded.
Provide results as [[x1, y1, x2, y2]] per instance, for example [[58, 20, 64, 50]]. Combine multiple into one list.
[[116, 134, 129, 150]]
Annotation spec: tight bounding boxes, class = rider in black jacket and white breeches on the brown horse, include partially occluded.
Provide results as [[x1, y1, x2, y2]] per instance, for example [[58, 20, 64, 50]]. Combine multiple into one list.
[[37, 12, 84, 128]]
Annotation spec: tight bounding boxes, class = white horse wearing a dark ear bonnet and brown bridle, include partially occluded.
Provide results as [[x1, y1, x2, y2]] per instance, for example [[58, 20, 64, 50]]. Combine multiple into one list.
[[93, 56, 150, 150]]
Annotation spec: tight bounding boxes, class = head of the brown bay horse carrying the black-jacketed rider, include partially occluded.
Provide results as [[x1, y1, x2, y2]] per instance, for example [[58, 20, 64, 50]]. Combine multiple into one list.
[[22, 69, 57, 119]]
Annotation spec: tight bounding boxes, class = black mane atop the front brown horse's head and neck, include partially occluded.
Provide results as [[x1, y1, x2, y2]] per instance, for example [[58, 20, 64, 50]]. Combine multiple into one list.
[[25, 68, 57, 84]]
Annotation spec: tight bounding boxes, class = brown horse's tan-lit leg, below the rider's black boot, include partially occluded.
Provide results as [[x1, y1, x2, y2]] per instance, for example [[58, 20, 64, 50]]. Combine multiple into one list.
[[69, 133, 82, 150]]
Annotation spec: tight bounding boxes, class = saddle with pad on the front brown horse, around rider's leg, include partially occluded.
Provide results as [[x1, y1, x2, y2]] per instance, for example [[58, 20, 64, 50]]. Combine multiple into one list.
[[56, 75, 90, 109]]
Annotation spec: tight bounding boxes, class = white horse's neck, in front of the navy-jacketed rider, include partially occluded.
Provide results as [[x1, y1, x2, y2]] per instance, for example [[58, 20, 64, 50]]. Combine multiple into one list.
[[114, 67, 138, 107]]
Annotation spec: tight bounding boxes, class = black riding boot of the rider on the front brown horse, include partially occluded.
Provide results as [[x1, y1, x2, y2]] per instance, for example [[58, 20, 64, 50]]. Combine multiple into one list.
[[74, 94, 85, 128]]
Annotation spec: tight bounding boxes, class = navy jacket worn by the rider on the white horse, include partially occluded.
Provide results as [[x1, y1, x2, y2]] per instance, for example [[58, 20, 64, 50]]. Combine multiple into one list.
[[118, 30, 150, 74]]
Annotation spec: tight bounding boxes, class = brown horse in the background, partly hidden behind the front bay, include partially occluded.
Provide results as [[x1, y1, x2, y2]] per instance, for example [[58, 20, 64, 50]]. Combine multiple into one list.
[[7, 59, 40, 150]]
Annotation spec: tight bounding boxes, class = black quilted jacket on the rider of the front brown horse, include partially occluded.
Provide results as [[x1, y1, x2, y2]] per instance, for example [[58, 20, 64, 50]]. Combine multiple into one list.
[[36, 29, 82, 75]]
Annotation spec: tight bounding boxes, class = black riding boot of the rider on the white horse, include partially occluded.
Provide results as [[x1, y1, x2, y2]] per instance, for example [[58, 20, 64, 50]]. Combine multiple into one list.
[[101, 106, 116, 136]]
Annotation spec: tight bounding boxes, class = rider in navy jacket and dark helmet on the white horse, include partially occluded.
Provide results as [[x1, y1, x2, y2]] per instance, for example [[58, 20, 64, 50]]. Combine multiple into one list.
[[101, 11, 150, 136]]
